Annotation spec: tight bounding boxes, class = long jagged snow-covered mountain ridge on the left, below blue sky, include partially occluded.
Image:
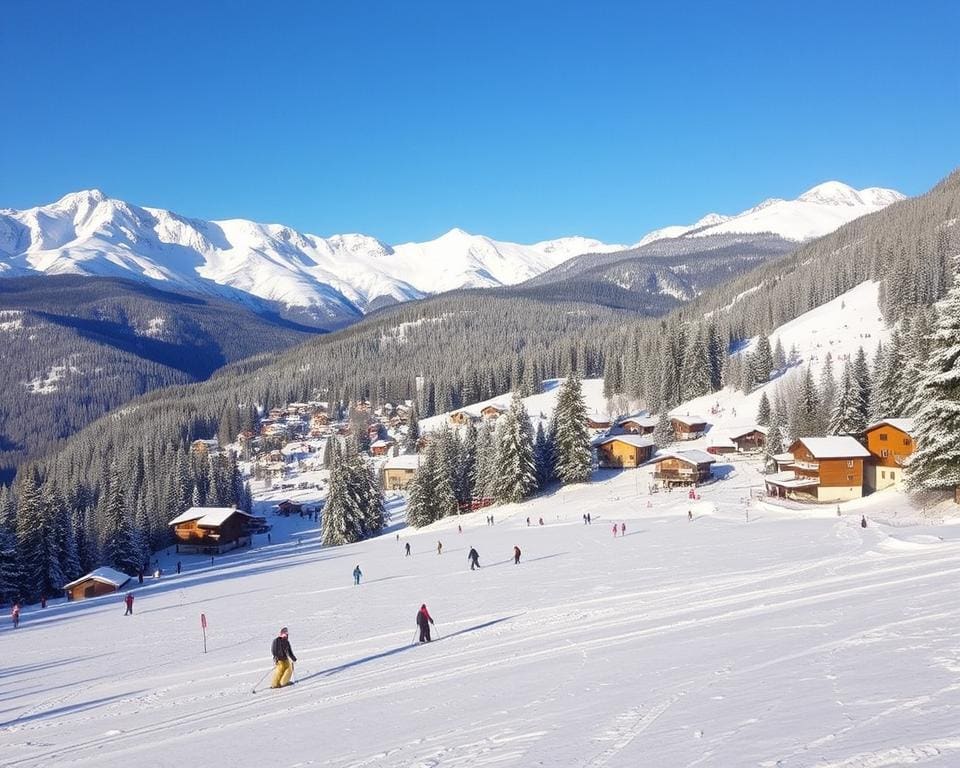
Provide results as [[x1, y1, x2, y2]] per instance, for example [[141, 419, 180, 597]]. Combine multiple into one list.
[[0, 190, 623, 321]]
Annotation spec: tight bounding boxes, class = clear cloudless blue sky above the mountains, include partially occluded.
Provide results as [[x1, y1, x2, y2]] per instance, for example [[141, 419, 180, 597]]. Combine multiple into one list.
[[0, 0, 960, 243]]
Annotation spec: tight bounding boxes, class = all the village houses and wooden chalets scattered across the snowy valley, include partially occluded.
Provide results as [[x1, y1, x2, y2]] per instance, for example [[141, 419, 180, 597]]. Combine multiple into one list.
[[56, 402, 915, 599]]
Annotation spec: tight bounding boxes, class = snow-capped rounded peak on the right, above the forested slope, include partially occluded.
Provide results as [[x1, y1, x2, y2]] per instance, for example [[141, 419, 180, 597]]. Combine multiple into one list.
[[634, 181, 904, 247]]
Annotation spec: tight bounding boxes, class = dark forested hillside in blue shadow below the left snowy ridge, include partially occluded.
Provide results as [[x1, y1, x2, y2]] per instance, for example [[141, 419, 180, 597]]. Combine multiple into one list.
[[0, 276, 311, 483]]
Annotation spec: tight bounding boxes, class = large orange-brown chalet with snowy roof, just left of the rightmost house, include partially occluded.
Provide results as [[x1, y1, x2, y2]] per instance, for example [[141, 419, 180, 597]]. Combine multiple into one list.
[[764, 435, 870, 502]]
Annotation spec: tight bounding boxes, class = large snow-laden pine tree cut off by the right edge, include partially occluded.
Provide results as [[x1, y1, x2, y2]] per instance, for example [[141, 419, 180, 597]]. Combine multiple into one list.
[[907, 259, 960, 493]]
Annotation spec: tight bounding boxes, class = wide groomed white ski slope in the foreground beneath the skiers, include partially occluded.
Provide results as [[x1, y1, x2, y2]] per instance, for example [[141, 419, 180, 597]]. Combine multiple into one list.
[[0, 469, 960, 768]]
